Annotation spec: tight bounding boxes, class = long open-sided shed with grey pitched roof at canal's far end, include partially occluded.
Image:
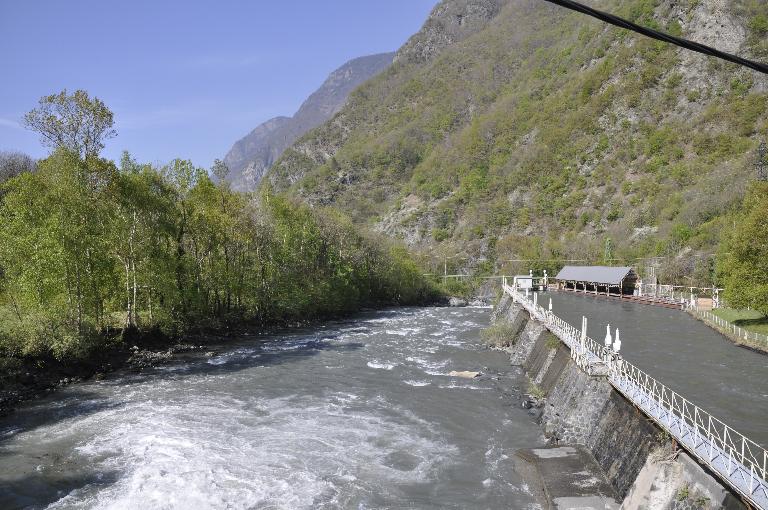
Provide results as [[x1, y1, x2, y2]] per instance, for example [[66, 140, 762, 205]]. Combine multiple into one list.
[[555, 266, 638, 296]]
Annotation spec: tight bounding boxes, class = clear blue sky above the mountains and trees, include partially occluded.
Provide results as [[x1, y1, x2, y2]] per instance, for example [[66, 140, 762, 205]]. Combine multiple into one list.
[[0, 0, 436, 167]]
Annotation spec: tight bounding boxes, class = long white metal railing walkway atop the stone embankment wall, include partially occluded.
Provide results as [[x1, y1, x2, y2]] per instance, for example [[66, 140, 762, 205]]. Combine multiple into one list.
[[502, 279, 768, 510]]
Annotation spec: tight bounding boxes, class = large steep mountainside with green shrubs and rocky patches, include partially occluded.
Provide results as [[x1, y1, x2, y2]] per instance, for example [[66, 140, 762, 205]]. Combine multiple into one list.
[[268, 0, 768, 283]]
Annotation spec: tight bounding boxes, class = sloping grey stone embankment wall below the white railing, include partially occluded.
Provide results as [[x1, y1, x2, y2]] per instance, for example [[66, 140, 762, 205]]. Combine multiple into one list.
[[493, 294, 745, 510]]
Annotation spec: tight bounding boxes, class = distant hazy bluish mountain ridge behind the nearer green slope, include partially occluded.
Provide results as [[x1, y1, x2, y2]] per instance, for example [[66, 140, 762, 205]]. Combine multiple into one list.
[[224, 53, 394, 191]]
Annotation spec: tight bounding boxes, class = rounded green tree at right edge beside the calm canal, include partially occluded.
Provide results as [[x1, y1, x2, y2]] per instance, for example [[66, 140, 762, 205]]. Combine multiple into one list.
[[718, 181, 768, 314]]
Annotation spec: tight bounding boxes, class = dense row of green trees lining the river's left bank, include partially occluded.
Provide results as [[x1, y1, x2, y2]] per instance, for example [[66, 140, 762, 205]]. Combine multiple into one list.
[[0, 148, 437, 358]]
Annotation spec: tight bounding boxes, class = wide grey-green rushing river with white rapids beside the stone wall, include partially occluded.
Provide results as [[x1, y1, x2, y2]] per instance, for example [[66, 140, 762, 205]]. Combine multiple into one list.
[[0, 307, 544, 510]]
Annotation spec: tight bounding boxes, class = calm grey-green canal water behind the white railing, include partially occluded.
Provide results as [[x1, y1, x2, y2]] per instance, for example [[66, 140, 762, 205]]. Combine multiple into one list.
[[539, 292, 768, 447]]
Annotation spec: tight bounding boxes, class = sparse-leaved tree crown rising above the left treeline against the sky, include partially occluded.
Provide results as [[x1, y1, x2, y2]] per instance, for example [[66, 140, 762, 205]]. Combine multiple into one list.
[[24, 89, 117, 159]]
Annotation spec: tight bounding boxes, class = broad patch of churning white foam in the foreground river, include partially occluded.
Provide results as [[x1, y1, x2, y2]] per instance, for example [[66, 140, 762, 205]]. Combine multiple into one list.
[[49, 393, 456, 509]]
